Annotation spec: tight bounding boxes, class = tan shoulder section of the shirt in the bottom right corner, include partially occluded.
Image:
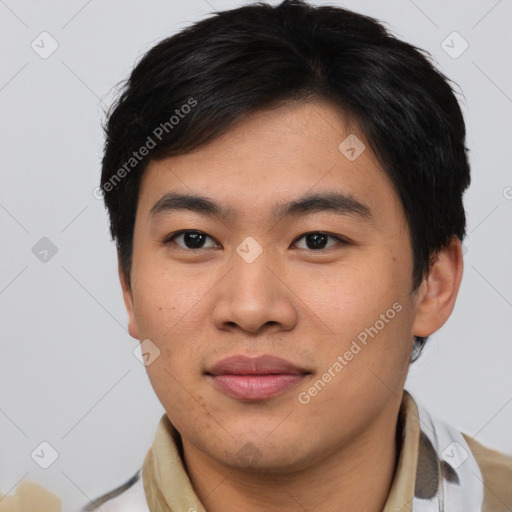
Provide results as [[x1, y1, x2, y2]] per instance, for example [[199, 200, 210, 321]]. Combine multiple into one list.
[[462, 433, 512, 512]]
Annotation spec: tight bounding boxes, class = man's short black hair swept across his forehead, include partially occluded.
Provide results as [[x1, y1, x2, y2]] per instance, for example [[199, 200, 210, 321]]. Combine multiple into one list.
[[100, 0, 470, 359]]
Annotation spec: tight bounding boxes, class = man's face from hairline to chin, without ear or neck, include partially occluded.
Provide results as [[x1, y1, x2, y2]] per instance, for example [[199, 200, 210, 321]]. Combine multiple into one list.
[[124, 101, 417, 471]]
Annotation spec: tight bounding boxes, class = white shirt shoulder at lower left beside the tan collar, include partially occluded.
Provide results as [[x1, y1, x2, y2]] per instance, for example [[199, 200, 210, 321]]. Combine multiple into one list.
[[80, 469, 150, 512]]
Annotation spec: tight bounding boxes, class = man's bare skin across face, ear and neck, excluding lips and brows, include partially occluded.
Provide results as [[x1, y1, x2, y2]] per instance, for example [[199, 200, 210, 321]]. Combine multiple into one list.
[[119, 100, 462, 512]]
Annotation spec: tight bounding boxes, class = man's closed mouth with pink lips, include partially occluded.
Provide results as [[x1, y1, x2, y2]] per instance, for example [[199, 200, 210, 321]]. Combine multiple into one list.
[[206, 355, 311, 401]]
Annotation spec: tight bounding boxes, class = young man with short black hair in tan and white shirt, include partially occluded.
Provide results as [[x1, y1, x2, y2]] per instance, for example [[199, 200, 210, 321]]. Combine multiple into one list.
[[84, 0, 512, 512]]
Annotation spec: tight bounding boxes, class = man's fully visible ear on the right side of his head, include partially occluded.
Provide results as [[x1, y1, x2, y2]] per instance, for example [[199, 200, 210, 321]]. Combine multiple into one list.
[[412, 236, 464, 337]]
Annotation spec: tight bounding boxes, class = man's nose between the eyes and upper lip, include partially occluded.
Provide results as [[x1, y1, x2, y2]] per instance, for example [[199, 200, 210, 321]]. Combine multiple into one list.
[[212, 250, 298, 334]]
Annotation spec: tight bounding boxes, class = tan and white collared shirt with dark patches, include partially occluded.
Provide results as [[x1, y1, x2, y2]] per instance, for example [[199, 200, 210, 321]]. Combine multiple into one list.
[[0, 390, 512, 512]]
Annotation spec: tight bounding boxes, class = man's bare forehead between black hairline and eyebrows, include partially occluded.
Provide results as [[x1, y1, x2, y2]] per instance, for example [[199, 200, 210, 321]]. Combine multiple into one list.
[[139, 101, 400, 226]]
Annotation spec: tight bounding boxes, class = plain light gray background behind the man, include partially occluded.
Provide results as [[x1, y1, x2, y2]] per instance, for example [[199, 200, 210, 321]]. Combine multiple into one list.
[[0, 0, 512, 511]]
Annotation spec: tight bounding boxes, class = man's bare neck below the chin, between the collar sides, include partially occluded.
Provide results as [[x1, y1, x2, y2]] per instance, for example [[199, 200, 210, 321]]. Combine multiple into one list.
[[183, 400, 400, 512]]
